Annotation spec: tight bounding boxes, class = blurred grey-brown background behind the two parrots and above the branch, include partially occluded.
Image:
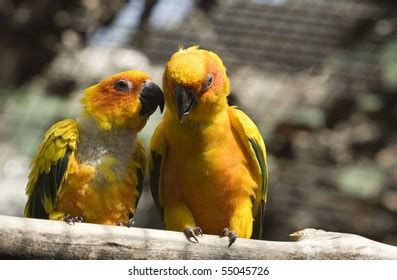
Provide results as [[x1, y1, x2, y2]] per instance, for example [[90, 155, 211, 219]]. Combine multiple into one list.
[[0, 0, 397, 245]]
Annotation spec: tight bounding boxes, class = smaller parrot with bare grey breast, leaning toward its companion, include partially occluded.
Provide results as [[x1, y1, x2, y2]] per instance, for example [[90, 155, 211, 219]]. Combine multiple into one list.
[[24, 70, 164, 226]]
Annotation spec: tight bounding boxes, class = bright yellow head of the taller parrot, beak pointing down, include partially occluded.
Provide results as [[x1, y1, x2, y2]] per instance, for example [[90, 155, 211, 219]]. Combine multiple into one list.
[[163, 46, 230, 122]]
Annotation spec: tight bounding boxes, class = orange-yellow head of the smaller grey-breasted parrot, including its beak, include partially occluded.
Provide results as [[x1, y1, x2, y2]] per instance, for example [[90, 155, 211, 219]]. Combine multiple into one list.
[[81, 70, 164, 131]]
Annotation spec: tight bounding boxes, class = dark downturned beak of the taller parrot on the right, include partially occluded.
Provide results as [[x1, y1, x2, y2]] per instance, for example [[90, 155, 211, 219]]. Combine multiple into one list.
[[174, 85, 197, 122]]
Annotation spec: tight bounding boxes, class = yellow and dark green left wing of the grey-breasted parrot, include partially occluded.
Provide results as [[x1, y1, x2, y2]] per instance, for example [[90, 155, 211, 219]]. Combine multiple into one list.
[[24, 119, 79, 219]]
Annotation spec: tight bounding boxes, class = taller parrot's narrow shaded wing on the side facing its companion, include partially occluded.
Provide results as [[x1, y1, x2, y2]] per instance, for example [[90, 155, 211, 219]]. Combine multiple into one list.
[[149, 123, 168, 218]]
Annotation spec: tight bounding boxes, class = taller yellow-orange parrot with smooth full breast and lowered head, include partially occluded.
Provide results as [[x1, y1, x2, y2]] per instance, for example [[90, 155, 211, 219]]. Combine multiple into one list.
[[149, 46, 268, 247]]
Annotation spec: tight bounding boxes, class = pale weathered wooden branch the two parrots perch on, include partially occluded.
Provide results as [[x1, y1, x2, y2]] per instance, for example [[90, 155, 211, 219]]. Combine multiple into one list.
[[0, 216, 397, 259]]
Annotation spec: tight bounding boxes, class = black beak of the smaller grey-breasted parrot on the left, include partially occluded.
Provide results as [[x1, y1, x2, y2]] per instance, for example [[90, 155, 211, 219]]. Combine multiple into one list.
[[139, 81, 164, 119]]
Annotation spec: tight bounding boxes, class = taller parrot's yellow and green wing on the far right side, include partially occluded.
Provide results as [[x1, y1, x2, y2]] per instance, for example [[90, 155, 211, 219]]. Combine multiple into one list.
[[230, 107, 268, 239]]
